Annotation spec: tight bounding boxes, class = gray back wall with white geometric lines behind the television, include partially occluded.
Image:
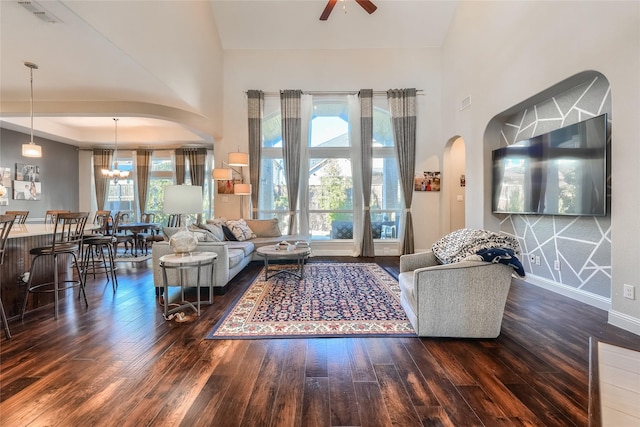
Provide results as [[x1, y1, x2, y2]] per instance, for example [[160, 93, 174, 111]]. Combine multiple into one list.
[[500, 75, 612, 298]]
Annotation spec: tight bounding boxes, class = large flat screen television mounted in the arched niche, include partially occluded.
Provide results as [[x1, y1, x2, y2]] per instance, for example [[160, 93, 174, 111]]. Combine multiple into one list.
[[492, 114, 607, 216]]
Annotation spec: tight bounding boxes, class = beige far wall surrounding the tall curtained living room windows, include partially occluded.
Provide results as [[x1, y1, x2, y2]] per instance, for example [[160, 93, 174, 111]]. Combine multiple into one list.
[[220, 49, 446, 254]]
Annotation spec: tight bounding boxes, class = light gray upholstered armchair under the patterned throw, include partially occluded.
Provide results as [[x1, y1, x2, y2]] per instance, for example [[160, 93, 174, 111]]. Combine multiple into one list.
[[398, 251, 513, 338]]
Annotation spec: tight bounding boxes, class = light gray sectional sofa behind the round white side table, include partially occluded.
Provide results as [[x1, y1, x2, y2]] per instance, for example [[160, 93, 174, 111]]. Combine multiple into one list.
[[152, 220, 306, 295]]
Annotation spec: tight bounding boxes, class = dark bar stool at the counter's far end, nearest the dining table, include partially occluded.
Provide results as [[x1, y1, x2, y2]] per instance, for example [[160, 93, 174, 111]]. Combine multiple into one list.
[[82, 211, 118, 292]]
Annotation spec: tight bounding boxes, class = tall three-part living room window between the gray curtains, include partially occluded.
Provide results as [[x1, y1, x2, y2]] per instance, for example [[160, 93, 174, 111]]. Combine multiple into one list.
[[258, 96, 402, 240]]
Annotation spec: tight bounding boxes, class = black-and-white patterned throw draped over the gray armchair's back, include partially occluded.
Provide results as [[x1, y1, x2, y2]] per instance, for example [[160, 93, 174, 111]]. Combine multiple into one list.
[[431, 228, 520, 264]]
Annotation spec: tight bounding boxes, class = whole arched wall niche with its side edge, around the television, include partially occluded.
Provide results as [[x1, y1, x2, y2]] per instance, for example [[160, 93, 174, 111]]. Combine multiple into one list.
[[484, 71, 613, 309]]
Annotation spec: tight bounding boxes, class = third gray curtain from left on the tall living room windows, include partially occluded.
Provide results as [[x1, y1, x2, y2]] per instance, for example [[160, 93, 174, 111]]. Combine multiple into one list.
[[360, 89, 375, 257]]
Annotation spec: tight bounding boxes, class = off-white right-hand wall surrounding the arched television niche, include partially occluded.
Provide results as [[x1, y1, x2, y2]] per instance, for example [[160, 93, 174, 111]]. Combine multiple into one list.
[[442, 1, 640, 334]]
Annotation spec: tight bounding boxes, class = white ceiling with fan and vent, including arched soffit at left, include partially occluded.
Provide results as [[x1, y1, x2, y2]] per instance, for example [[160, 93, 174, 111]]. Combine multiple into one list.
[[0, 0, 456, 147]]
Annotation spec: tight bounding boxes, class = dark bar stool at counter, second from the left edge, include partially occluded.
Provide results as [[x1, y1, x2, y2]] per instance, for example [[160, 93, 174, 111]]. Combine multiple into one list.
[[20, 212, 89, 319]]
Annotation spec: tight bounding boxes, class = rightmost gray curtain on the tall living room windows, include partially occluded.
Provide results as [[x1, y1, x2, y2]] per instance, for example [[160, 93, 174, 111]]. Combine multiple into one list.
[[387, 88, 416, 254]]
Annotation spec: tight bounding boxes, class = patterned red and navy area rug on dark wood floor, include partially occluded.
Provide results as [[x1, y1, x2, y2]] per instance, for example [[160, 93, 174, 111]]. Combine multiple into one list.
[[207, 263, 415, 339]]
